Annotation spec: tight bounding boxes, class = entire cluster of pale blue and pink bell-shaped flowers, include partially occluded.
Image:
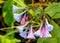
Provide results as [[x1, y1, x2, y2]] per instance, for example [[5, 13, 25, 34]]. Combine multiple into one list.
[[13, 5, 53, 39]]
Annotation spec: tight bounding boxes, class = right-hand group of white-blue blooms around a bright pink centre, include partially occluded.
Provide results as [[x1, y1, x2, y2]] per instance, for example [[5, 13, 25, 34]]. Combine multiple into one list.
[[34, 18, 53, 37]]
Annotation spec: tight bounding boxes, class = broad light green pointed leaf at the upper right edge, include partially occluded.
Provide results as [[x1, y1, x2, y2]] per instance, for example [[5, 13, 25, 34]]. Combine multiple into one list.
[[44, 2, 60, 19]]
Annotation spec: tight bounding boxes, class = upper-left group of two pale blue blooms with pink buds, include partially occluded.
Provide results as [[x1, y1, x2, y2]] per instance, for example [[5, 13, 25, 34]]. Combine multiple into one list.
[[13, 5, 28, 25]]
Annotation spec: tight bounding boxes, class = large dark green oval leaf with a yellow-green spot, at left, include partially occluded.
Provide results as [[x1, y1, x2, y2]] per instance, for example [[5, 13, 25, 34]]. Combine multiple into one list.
[[3, 0, 14, 26]]
